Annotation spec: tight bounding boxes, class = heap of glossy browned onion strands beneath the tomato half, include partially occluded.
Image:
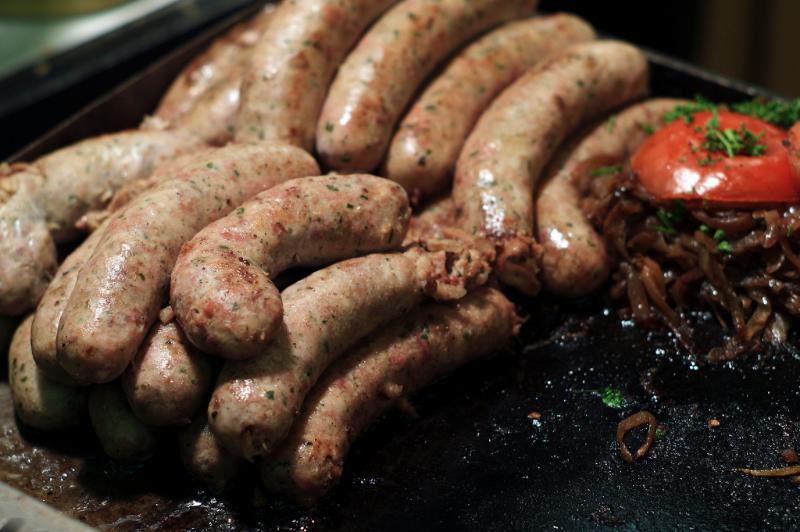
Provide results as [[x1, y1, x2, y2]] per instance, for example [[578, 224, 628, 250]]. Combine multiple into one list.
[[575, 160, 800, 360]]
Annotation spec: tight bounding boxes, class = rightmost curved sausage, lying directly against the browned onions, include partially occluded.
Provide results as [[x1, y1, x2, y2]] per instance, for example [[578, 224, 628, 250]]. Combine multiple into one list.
[[536, 99, 686, 297]]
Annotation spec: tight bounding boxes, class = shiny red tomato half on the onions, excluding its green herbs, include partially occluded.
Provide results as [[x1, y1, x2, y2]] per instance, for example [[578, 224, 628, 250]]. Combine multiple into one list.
[[631, 111, 800, 207]]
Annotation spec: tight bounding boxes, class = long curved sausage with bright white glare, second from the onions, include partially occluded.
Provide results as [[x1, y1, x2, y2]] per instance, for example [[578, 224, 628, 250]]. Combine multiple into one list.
[[453, 41, 648, 295]]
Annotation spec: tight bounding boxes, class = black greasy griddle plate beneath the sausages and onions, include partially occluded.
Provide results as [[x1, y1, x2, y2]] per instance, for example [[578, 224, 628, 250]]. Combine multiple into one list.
[[0, 5, 800, 530]]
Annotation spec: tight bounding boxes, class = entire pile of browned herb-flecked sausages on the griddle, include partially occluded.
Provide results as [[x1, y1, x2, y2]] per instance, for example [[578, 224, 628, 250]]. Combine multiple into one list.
[[0, 0, 676, 500]]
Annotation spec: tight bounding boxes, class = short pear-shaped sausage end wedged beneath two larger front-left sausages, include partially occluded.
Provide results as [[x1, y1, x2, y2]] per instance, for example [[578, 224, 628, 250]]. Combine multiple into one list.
[[122, 321, 216, 427]]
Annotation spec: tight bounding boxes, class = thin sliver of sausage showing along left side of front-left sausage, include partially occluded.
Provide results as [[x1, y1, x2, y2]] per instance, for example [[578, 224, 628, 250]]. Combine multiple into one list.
[[31, 218, 108, 386]]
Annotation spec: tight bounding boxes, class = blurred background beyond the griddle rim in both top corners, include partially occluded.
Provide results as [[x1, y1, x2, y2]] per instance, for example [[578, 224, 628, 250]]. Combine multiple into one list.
[[0, 0, 800, 160]]
